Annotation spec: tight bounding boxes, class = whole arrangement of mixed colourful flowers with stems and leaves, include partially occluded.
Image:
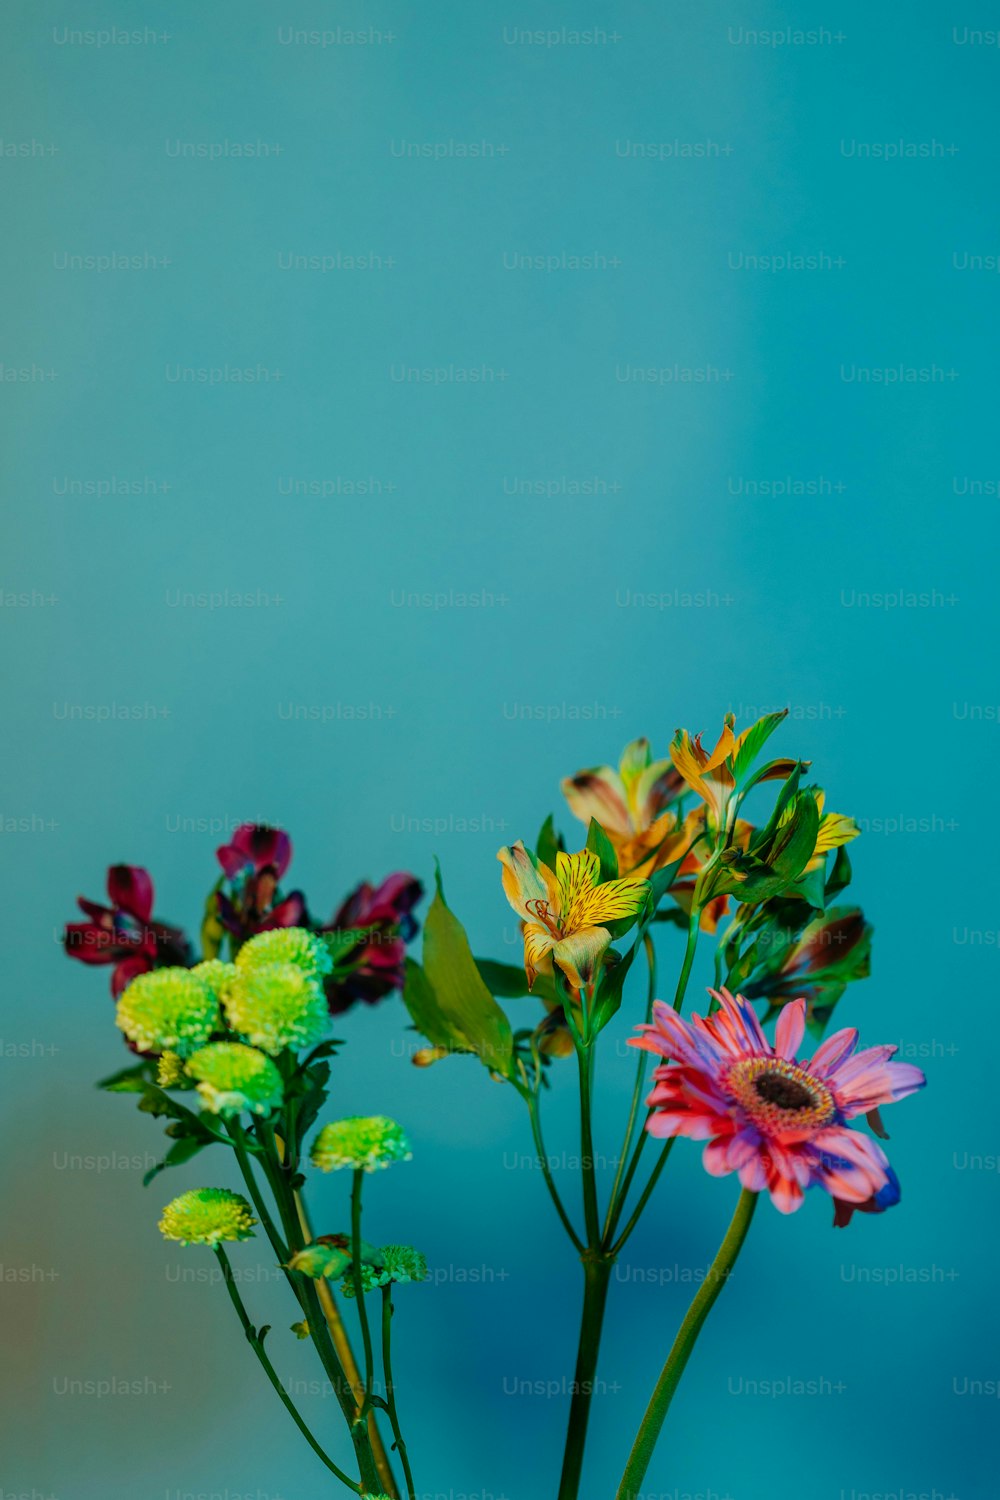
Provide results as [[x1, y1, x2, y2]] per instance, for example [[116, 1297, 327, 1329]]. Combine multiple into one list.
[[66, 714, 925, 1500]]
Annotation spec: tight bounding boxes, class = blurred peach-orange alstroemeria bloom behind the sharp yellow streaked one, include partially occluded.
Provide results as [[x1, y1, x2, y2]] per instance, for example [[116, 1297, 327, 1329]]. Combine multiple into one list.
[[562, 740, 693, 879]]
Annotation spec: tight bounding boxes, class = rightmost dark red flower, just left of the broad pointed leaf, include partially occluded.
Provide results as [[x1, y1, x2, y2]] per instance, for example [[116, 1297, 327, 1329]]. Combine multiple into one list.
[[321, 870, 424, 1016]]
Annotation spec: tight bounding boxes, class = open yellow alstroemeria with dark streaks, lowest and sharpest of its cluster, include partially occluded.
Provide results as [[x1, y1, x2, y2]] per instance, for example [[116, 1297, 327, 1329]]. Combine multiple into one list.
[[496, 839, 649, 990]]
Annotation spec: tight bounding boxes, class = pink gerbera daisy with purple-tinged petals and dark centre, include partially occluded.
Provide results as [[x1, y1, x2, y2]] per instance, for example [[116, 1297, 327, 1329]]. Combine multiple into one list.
[[631, 990, 927, 1214]]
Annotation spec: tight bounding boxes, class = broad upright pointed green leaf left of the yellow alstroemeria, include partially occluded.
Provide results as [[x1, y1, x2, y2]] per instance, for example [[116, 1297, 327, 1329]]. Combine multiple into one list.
[[423, 870, 514, 1076]]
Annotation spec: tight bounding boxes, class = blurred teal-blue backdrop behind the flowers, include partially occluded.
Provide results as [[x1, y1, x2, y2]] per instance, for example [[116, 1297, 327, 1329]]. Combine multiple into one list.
[[0, 0, 1000, 1500]]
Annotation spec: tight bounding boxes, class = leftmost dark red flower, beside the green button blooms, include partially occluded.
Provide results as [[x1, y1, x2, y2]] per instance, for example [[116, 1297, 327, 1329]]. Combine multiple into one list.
[[63, 864, 193, 999]]
